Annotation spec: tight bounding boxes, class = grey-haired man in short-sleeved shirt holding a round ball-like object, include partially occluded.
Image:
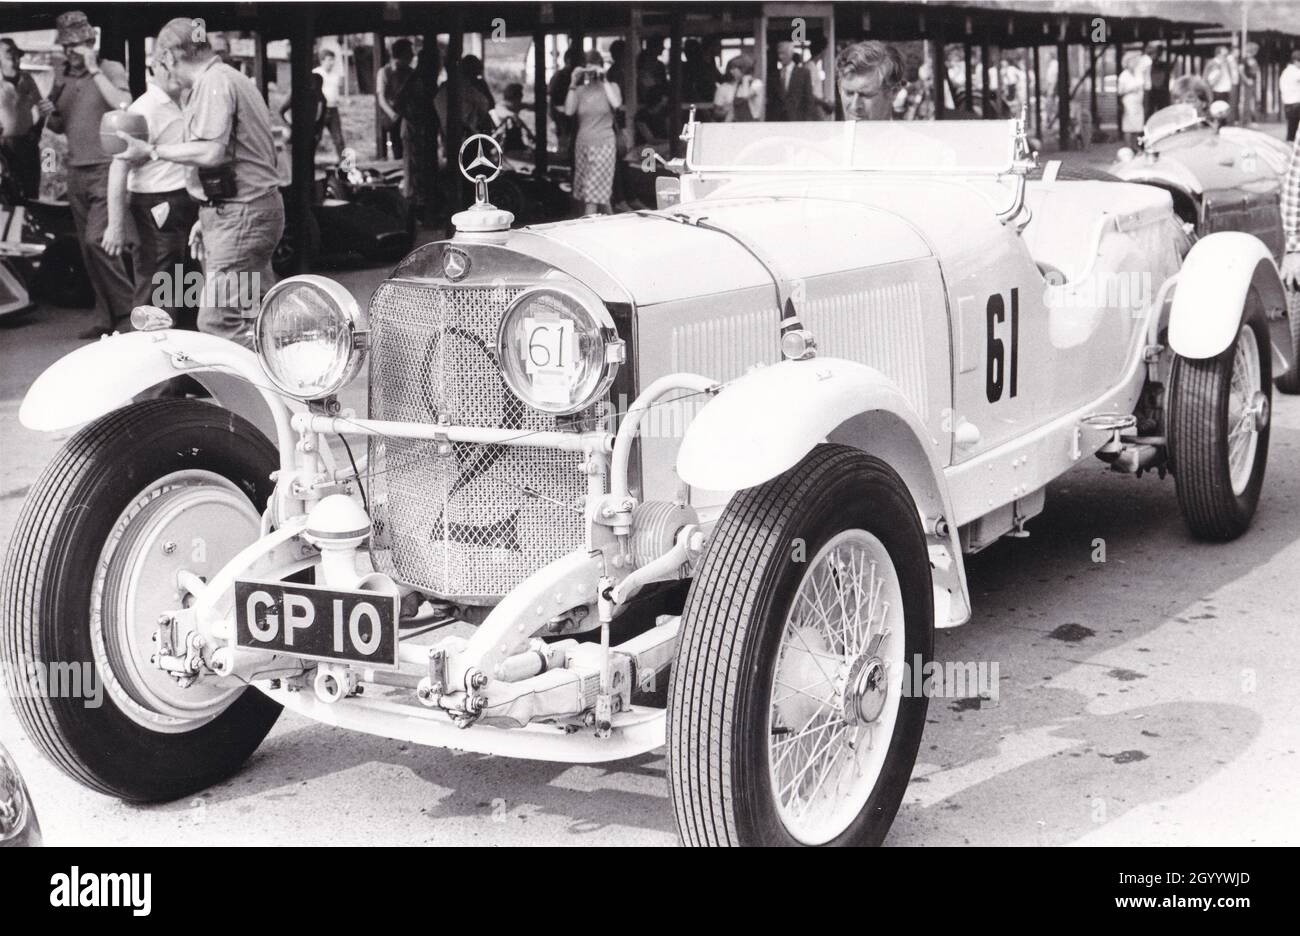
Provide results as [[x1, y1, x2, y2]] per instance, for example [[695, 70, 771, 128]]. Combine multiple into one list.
[[118, 17, 285, 347]]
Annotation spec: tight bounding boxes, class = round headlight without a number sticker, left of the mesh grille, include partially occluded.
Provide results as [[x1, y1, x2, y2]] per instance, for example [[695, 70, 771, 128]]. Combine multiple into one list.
[[254, 276, 369, 400]]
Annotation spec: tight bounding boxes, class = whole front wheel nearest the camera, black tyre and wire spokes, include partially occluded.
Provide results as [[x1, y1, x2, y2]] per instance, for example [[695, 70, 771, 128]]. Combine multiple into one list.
[[667, 445, 933, 845]]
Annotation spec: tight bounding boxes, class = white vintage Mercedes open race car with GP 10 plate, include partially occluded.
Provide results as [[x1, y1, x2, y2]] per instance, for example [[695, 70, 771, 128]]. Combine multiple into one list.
[[3, 120, 1291, 845]]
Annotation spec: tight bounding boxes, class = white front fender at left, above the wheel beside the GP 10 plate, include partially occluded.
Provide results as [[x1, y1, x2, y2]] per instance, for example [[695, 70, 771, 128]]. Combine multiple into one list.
[[18, 329, 294, 458]]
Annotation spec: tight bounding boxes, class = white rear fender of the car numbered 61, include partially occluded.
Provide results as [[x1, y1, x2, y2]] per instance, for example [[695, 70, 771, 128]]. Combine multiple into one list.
[[1169, 231, 1292, 377]]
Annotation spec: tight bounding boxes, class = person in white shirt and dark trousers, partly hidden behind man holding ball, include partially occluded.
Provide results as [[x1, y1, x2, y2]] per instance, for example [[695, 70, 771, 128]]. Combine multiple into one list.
[[100, 62, 199, 321]]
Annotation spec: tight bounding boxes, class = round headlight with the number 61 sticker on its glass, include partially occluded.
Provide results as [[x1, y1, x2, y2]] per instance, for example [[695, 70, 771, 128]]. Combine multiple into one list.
[[497, 286, 624, 415]]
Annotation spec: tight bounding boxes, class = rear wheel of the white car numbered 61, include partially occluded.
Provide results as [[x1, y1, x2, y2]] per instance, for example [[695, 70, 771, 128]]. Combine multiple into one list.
[[1169, 300, 1273, 541]]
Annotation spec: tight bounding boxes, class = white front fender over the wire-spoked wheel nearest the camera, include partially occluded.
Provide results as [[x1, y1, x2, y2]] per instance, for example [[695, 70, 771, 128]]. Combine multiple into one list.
[[677, 358, 970, 628]]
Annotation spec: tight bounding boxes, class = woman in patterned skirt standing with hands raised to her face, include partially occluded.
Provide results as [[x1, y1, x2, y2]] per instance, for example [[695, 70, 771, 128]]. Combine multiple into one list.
[[564, 49, 623, 215]]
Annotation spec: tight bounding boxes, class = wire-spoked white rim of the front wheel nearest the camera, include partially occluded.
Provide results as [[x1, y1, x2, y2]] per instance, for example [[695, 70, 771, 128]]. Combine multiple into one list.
[[766, 529, 905, 845]]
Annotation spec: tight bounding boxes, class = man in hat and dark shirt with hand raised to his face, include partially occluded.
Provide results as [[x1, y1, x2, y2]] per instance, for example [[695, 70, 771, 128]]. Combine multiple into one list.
[[40, 10, 134, 339]]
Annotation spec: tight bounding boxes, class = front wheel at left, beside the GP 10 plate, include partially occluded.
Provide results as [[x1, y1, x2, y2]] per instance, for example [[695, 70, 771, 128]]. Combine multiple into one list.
[[0, 400, 281, 801]]
